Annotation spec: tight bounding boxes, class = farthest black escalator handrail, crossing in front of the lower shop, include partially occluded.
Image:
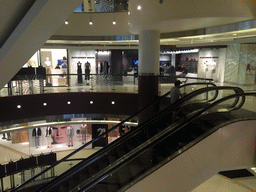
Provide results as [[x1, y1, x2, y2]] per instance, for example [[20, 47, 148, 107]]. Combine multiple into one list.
[[12, 82, 216, 191]]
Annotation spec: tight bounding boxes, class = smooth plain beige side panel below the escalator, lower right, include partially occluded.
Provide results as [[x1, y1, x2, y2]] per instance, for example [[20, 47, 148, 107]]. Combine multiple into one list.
[[126, 120, 256, 192]]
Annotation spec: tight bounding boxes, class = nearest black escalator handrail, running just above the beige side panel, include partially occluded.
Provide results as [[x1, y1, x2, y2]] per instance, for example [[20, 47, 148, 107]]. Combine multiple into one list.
[[76, 92, 256, 190]]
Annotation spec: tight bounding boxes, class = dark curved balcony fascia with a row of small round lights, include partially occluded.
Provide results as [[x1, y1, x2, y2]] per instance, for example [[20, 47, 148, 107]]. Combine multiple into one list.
[[0, 92, 138, 122]]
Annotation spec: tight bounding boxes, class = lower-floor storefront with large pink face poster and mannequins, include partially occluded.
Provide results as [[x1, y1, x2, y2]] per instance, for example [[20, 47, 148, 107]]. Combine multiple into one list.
[[0, 118, 137, 155]]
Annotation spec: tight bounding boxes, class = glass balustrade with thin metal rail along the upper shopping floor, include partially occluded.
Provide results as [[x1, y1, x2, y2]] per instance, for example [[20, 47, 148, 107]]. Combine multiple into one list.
[[0, 74, 212, 97]]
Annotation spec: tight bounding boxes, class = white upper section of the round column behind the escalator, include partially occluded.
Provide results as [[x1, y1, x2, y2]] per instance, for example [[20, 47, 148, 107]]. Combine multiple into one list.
[[139, 30, 160, 75]]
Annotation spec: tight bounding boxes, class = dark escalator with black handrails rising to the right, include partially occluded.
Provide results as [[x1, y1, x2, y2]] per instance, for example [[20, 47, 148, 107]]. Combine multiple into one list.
[[13, 85, 249, 192]]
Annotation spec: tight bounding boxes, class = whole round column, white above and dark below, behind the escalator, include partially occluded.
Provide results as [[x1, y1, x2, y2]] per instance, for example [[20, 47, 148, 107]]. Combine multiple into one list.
[[138, 30, 160, 123]]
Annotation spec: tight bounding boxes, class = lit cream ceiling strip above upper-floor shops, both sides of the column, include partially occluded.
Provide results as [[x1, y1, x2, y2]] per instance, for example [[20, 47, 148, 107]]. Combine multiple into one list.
[[45, 28, 256, 49]]
